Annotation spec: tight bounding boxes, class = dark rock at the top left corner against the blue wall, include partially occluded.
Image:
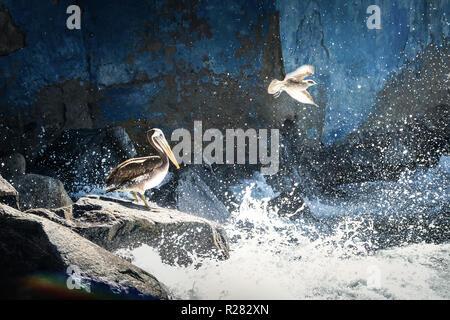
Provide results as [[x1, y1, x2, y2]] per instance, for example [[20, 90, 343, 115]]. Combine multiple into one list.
[[0, 5, 25, 56]]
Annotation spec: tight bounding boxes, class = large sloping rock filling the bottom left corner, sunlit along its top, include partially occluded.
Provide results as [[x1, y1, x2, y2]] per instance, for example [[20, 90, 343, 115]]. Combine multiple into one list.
[[0, 204, 168, 299]]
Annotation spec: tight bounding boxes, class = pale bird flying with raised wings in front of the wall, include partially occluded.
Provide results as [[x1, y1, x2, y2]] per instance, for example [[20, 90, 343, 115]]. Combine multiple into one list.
[[267, 65, 317, 106]]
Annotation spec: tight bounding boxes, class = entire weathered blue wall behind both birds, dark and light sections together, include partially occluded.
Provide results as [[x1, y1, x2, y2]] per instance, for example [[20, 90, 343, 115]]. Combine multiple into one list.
[[0, 0, 450, 178]]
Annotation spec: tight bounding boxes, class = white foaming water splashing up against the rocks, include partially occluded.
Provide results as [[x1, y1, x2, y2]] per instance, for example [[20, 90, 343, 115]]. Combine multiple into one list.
[[113, 157, 450, 299]]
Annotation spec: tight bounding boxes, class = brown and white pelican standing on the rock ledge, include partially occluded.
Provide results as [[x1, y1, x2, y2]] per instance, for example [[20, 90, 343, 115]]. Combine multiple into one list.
[[106, 128, 180, 207]]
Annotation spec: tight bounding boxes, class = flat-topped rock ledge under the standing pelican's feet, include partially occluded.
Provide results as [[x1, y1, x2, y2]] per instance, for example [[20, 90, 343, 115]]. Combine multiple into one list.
[[27, 196, 229, 265]]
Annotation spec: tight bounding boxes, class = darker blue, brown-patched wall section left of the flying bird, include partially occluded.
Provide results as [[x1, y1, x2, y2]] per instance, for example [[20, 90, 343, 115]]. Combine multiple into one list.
[[0, 0, 283, 155]]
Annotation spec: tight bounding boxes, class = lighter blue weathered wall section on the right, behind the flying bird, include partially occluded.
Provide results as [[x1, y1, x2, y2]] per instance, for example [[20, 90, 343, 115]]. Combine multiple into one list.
[[276, 0, 450, 144]]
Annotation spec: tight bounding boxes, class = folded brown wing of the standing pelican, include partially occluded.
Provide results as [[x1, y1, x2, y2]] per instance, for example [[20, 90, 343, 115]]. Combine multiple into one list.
[[105, 156, 162, 186]]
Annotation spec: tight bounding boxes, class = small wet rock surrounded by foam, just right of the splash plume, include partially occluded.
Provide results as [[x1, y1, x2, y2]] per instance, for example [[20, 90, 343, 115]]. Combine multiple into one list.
[[268, 188, 314, 221]]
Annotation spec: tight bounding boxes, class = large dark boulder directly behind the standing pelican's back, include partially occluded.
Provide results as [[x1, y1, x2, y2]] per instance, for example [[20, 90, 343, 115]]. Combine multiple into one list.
[[34, 127, 136, 192]]
